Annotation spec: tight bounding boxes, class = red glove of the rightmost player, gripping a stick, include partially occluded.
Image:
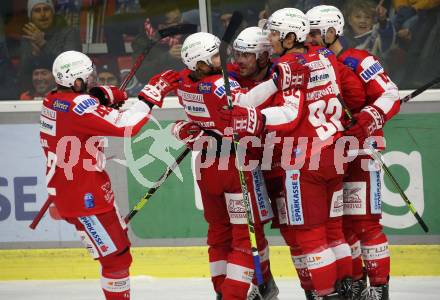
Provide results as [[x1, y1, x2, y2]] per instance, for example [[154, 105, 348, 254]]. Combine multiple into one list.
[[344, 106, 384, 140]]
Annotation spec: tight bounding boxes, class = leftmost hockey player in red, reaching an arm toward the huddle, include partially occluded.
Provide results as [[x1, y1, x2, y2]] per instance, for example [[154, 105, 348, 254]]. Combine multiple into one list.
[[40, 51, 178, 300]]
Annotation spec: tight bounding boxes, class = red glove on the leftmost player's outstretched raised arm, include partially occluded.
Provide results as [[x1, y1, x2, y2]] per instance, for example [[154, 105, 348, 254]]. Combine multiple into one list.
[[138, 70, 180, 107]]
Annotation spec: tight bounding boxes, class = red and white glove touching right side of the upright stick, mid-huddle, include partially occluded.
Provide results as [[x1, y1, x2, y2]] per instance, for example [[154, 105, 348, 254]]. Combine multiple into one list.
[[220, 106, 265, 138]]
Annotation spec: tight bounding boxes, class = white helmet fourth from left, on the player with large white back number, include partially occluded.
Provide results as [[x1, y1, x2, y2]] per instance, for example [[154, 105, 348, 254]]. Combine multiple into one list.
[[266, 8, 310, 43]]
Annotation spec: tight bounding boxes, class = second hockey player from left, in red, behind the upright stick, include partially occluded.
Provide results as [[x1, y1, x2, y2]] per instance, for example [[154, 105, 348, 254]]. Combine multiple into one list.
[[173, 32, 306, 300]]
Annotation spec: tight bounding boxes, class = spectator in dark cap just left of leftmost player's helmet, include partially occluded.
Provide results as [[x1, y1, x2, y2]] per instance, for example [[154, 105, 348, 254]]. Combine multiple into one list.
[[20, 58, 56, 100]]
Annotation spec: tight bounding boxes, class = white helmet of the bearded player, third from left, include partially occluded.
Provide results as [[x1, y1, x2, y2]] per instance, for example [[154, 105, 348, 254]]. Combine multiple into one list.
[[233, 27, 272, 59]]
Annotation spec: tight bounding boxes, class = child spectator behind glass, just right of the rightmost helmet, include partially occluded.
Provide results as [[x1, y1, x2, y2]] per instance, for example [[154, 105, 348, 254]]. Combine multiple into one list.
[[344, 0, 396, 62]]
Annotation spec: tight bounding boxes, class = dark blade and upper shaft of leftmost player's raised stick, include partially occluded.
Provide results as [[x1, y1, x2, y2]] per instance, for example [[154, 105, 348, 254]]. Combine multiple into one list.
[[120, 24, 197, 90]]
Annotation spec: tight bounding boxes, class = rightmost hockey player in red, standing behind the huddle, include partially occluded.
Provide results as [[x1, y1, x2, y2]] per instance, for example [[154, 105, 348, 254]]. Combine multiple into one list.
[[307, 5, 400, 299]]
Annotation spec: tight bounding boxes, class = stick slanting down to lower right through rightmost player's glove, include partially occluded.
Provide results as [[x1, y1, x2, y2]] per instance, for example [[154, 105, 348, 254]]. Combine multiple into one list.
[[320, 55, 429, 232]]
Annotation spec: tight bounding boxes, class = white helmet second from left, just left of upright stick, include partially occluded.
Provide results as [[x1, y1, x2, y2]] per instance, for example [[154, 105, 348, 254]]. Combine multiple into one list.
[[181, 32, 220, 71]]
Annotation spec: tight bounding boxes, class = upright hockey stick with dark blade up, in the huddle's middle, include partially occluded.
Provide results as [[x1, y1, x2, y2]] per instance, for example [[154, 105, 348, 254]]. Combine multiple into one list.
[[219, 11, 266, 299]]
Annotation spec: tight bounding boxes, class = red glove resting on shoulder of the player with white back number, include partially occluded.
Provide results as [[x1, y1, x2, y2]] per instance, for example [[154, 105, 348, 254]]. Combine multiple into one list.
[[273, 61, 310, 91]]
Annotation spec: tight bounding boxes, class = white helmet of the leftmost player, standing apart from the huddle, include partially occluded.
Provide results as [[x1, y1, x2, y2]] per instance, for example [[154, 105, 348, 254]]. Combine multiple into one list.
[[52, 51, 94, 87]]
